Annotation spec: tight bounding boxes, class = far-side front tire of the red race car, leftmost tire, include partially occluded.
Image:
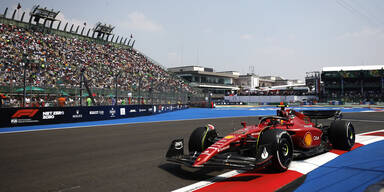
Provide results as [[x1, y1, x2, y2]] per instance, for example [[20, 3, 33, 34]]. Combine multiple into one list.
[[188, 127, 217, 153]]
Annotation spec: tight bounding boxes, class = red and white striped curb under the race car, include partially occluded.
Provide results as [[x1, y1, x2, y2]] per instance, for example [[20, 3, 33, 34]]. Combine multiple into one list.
[[174, 129, 384, 192]]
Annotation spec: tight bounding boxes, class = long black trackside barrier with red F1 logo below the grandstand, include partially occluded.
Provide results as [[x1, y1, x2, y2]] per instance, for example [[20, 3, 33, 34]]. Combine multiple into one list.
[[0, 104, 188, 128]]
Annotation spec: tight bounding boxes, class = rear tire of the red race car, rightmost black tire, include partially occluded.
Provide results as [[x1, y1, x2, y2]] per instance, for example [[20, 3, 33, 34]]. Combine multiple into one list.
[[328, 120, 356, 151]]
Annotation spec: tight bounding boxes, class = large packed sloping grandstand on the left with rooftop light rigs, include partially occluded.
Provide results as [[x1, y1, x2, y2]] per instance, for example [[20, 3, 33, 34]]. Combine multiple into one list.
[[0, 6, 202, 107]]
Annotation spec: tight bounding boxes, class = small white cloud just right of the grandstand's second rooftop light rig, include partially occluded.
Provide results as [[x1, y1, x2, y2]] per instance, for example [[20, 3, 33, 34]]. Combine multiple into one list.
[[119, 11, 164, 32]]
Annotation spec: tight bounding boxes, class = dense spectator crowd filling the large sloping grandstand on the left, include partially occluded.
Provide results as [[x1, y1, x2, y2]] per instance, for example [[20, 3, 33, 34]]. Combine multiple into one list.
[[0, 24, 196, 107]]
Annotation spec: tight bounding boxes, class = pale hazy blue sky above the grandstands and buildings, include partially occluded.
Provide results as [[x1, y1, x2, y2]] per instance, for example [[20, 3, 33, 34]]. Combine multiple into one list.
[[0, 0, 384, 80]]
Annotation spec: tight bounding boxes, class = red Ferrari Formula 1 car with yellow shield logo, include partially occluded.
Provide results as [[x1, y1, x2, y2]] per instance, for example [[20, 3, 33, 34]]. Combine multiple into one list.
[[166, 105, 355, 172]]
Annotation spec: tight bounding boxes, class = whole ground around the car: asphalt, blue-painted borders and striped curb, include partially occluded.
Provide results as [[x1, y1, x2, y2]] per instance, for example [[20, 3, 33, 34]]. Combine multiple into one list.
[[0, 107, 384, 192]]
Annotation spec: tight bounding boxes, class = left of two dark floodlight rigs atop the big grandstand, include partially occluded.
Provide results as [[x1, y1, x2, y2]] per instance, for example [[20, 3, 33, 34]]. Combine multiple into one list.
[[29, 5, 60, 29]]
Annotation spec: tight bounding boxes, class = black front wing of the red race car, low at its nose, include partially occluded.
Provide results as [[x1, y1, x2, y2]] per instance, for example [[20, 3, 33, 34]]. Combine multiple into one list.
[[166, 139, 273, 170]]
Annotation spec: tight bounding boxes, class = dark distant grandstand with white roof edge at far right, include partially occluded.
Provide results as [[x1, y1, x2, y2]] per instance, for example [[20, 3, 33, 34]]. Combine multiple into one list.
[[321, 65, 384, 103]]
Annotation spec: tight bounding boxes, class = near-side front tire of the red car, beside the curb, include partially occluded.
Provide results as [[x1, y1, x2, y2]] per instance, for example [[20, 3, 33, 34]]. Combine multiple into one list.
[[258, 129, 293, 172]]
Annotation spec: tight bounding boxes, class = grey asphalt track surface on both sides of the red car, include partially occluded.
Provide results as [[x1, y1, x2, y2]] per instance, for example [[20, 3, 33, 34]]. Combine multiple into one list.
[[0, 112, 384, 192]]
